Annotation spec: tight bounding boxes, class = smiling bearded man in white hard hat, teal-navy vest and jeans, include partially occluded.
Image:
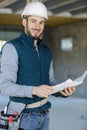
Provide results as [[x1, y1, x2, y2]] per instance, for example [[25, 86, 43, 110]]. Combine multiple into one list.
[[0, 2, 75, 130]]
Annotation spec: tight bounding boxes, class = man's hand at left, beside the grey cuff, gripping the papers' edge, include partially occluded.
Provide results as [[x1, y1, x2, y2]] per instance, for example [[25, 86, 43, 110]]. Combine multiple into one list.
[[32, 85, 54, 97]]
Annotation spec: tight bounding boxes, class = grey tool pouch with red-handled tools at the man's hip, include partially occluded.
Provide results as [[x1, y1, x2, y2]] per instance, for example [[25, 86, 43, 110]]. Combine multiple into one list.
[[0, 101, 25, 130]]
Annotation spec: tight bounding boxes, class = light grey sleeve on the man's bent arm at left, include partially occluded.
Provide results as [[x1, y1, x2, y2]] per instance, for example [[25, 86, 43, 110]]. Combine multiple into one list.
[[0, 43, 33, 98]]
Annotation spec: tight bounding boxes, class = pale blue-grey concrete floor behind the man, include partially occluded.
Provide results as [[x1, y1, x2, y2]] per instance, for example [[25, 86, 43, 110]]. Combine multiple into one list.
[[0, 95, 87, 130]]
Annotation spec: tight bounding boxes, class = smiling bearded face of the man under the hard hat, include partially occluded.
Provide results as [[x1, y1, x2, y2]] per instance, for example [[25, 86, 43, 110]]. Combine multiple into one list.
[[25, 16, 45, 38]]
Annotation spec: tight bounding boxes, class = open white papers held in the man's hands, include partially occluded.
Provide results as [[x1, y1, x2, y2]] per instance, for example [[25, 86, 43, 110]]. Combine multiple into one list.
[[51, 71, 87, 94]]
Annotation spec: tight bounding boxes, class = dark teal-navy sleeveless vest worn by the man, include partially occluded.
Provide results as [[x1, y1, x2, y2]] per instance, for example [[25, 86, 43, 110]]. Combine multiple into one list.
[[10, 33, 52, 111]]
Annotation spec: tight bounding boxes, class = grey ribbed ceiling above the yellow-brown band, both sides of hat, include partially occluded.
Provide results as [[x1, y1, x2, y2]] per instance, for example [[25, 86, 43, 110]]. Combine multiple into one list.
[[0, 0, 87, 17]]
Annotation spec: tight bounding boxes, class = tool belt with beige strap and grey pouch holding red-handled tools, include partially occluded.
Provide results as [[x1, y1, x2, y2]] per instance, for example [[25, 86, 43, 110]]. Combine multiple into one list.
[[0, 98, 48, 130]]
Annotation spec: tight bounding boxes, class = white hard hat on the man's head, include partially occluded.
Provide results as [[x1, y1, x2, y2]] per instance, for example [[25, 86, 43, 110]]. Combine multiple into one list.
[[21, 2, 48, 19]]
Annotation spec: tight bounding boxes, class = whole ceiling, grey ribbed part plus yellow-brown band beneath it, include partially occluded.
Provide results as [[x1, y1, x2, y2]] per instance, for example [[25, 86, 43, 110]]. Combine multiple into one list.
[[0, 0, 87, 25]]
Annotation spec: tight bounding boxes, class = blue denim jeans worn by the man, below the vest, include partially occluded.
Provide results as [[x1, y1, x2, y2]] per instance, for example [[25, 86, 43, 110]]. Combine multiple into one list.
[[19, 112, 49, 130]]
